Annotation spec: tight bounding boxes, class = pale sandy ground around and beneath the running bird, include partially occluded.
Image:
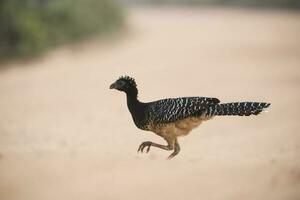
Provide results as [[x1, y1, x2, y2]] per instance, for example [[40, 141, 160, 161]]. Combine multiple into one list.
[[0, 8, 300, 200]]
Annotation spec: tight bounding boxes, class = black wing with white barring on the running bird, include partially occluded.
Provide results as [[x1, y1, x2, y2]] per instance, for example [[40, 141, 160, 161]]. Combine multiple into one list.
[[148, 97, 220, 123]]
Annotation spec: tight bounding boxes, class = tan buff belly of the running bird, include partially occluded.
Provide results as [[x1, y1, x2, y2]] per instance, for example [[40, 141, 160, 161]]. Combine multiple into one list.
[[148, 117, 210, 138]]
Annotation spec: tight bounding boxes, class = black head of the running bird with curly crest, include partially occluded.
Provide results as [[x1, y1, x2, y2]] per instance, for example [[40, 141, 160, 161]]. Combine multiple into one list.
[[109, 76, 137, 93]]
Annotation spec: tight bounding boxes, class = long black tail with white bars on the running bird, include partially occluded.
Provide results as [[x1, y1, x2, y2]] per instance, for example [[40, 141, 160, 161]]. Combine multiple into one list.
[[205, 102, 271, 116]]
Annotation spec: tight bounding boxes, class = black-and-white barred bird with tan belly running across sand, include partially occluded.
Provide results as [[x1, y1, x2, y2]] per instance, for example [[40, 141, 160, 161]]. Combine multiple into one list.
[[110, 75, 271, 159]]
